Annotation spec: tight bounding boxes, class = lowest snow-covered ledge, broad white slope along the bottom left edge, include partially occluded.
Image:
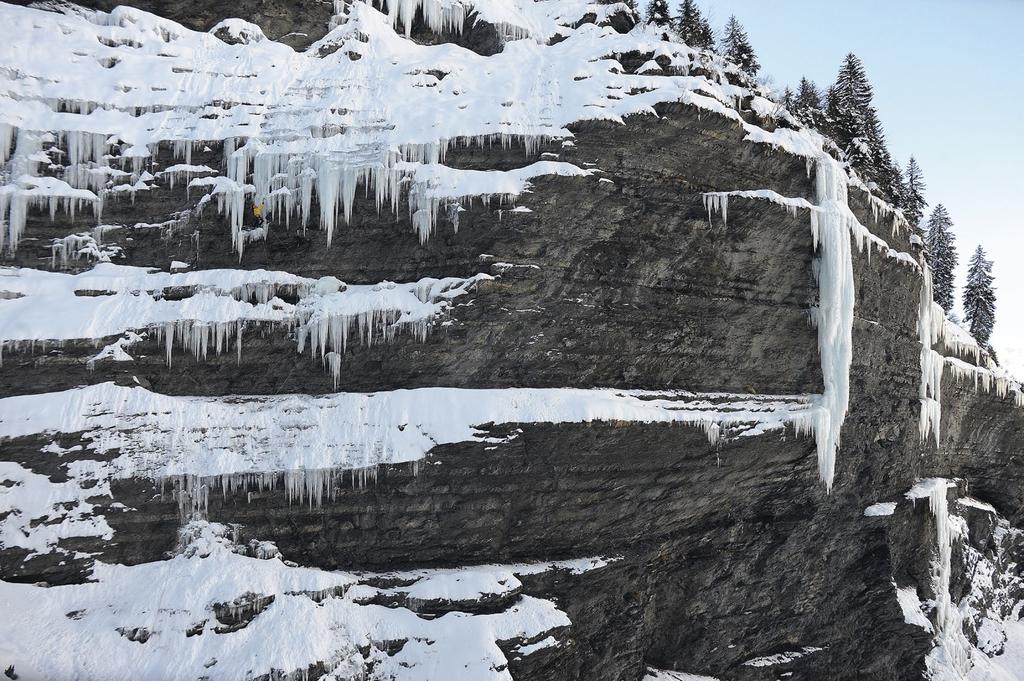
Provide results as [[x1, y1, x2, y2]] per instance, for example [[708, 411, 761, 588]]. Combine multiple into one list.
[[0, 522, 606, 680]]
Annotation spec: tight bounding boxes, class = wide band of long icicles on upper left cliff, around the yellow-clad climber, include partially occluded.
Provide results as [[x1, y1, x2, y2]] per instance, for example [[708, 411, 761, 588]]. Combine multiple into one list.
[[0, 85, 548, 259]]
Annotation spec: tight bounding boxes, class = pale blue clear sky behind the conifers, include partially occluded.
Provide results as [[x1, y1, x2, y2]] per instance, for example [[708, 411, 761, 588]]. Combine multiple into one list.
[[692, 0, 1024, 372]]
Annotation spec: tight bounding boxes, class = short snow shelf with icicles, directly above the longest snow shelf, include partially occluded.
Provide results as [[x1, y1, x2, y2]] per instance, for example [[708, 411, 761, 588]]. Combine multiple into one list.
[[0, 263, 493, 383]]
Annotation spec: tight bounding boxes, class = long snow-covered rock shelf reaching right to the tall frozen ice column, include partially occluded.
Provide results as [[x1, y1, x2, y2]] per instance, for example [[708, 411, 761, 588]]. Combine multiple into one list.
[[0, 383, 812, 506]]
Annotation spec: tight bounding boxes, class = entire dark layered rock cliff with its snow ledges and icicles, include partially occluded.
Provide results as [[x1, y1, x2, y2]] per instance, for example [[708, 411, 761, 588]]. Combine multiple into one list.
[[0, 0, 1024, 679]]
